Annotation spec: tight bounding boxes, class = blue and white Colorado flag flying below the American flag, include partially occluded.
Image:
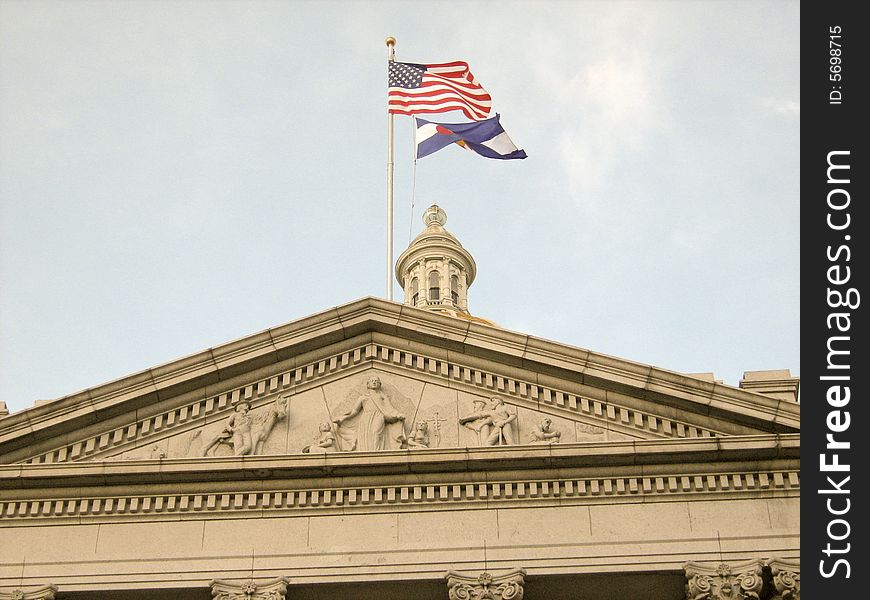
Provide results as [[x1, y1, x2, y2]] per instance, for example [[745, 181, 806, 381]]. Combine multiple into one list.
[[415, 115, 526, 160]]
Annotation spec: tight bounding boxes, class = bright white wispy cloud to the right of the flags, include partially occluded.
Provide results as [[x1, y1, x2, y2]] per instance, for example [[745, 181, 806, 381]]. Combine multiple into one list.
[[528, 5, 669, 206]]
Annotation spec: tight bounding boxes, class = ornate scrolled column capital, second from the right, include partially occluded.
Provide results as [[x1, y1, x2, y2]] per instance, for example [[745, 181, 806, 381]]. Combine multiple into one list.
[[685, 560, 765, 600]]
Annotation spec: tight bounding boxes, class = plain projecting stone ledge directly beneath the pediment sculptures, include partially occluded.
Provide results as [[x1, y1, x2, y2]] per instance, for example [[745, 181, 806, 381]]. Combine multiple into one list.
[[0, 434, 800, 490]]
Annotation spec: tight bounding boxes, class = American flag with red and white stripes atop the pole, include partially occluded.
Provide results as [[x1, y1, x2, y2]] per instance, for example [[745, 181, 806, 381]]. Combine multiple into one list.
[[388, 61, 492, 121]]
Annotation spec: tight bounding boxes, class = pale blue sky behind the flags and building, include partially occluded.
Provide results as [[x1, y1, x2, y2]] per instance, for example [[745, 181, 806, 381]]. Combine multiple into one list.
[[0, 0, 800, 412]]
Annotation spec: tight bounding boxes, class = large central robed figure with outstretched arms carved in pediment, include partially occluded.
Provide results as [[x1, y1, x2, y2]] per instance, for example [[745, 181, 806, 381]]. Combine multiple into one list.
[[333, 375, 405, 451]]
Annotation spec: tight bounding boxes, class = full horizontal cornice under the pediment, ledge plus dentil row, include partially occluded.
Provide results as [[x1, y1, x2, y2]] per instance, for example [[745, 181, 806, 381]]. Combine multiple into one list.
[[0, 434, 800, 527]]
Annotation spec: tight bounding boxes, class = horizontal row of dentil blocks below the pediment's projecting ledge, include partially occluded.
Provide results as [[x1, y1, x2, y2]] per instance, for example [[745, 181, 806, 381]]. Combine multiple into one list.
[[0, 450, 800, 527]]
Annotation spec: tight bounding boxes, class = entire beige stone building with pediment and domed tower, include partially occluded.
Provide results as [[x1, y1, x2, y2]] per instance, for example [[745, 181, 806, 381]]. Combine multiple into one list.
[[0, 207, 800, 600]]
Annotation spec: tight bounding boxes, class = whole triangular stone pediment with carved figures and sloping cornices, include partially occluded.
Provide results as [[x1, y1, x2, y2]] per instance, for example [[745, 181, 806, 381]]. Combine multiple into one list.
[[0, 298, 800, 463]]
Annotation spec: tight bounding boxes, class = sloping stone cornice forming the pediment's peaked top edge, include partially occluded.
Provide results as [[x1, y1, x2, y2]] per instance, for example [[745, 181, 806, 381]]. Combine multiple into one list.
[[0, 298, 800, 458]]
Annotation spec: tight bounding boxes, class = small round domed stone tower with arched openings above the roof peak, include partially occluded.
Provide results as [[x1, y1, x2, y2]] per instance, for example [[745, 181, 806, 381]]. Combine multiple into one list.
[[396, 204, 477, 316]]
